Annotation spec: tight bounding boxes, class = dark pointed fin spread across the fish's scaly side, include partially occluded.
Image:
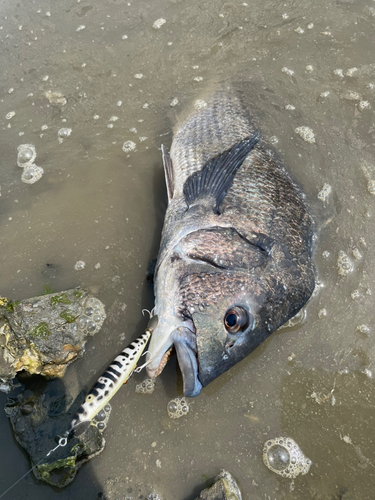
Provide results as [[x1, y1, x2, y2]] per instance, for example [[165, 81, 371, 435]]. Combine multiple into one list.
[[184, 132, 261, 211]]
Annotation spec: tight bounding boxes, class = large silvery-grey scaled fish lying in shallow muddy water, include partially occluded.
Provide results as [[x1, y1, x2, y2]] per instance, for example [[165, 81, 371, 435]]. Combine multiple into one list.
[[146, 88, 315, 397]]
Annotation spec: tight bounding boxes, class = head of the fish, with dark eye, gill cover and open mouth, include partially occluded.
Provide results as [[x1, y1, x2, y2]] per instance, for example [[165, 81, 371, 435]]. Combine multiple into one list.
[[147, 231, 308, 396]]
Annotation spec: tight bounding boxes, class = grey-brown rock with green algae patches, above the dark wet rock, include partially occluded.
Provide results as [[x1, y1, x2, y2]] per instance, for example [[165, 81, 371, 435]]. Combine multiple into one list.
[[0, 288, 106, 392]]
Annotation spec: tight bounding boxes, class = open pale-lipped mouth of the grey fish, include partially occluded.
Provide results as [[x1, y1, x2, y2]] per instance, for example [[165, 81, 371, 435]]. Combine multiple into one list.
[[146, 326, 202, 397]]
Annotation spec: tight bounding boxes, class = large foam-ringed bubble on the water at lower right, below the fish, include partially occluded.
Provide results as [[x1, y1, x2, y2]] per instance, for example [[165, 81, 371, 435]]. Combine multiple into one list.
[[263, 437, 312, 479]]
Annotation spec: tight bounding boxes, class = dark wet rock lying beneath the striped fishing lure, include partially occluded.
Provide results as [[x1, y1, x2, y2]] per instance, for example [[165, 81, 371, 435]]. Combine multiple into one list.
[[5, 383, 111, 488]]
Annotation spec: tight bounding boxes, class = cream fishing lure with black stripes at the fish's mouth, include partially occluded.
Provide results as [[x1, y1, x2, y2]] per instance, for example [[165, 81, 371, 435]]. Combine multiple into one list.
[[65, 316, 157, 438]]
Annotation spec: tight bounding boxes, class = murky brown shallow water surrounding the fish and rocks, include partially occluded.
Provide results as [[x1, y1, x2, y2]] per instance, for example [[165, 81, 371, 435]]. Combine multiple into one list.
[[0, 0, 375, 500]]
